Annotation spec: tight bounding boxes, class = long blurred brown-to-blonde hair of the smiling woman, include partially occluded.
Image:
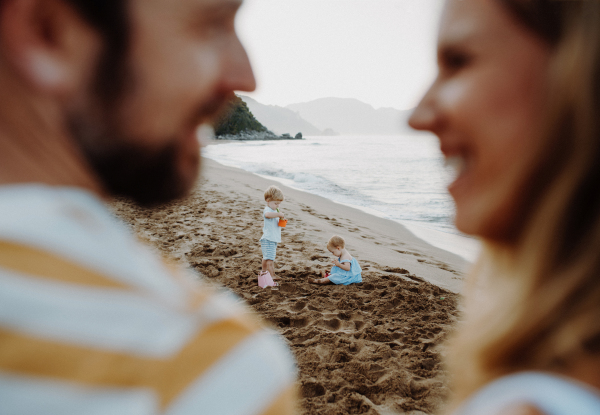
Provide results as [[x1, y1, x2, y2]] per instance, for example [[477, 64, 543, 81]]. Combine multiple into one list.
[[448, 0, 600, 408]]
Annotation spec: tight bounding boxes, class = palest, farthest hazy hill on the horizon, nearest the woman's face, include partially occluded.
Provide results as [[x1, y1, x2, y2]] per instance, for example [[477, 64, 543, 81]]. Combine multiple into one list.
[[286, 98, 412, 135]]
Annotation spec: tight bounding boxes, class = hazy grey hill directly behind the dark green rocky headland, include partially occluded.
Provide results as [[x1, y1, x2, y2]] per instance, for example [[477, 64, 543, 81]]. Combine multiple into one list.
[[239, 95, 323, 136]]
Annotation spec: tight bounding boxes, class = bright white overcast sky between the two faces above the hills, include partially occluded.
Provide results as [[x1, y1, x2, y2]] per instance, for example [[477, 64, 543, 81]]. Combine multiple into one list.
[[236, 0, 443, 110]]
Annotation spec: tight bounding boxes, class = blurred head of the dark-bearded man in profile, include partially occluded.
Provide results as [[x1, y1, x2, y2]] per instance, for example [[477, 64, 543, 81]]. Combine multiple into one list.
[[0, 0, 255, 203]]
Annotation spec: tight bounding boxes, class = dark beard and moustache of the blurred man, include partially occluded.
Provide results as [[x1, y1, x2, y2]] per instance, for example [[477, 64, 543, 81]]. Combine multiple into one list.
[[68, 59, 232, 206]]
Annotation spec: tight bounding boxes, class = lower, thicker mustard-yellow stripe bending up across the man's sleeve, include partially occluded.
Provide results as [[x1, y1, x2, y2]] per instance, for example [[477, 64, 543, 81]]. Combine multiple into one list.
[[0, 321, 252, 406]]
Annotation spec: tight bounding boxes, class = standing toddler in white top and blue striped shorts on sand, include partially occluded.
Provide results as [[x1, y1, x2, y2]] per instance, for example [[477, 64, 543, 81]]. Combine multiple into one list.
[[259, 186, 284, 285]]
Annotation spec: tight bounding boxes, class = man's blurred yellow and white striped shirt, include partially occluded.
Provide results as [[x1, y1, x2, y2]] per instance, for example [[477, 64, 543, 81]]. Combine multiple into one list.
[[0, 185, 296, 415]]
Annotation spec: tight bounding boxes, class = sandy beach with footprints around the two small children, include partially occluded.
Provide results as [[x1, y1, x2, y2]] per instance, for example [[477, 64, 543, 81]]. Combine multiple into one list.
[[113, 159, 469, 414]]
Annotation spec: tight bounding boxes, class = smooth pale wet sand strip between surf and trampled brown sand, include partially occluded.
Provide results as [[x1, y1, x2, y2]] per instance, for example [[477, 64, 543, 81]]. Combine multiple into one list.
[[202, 157, 471, 293]]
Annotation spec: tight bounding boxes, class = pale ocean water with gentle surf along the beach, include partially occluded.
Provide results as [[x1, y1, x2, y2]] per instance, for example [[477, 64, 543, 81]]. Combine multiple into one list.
[[203, 133, 478, 261]]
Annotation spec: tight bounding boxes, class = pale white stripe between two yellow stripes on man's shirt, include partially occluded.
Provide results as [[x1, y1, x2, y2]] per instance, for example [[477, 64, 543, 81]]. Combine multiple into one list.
[[0, 269, 243, 358]]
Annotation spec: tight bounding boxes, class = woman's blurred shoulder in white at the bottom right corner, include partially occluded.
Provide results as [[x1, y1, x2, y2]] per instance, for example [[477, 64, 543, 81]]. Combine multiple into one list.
[[455, 372, 600, 415]]
